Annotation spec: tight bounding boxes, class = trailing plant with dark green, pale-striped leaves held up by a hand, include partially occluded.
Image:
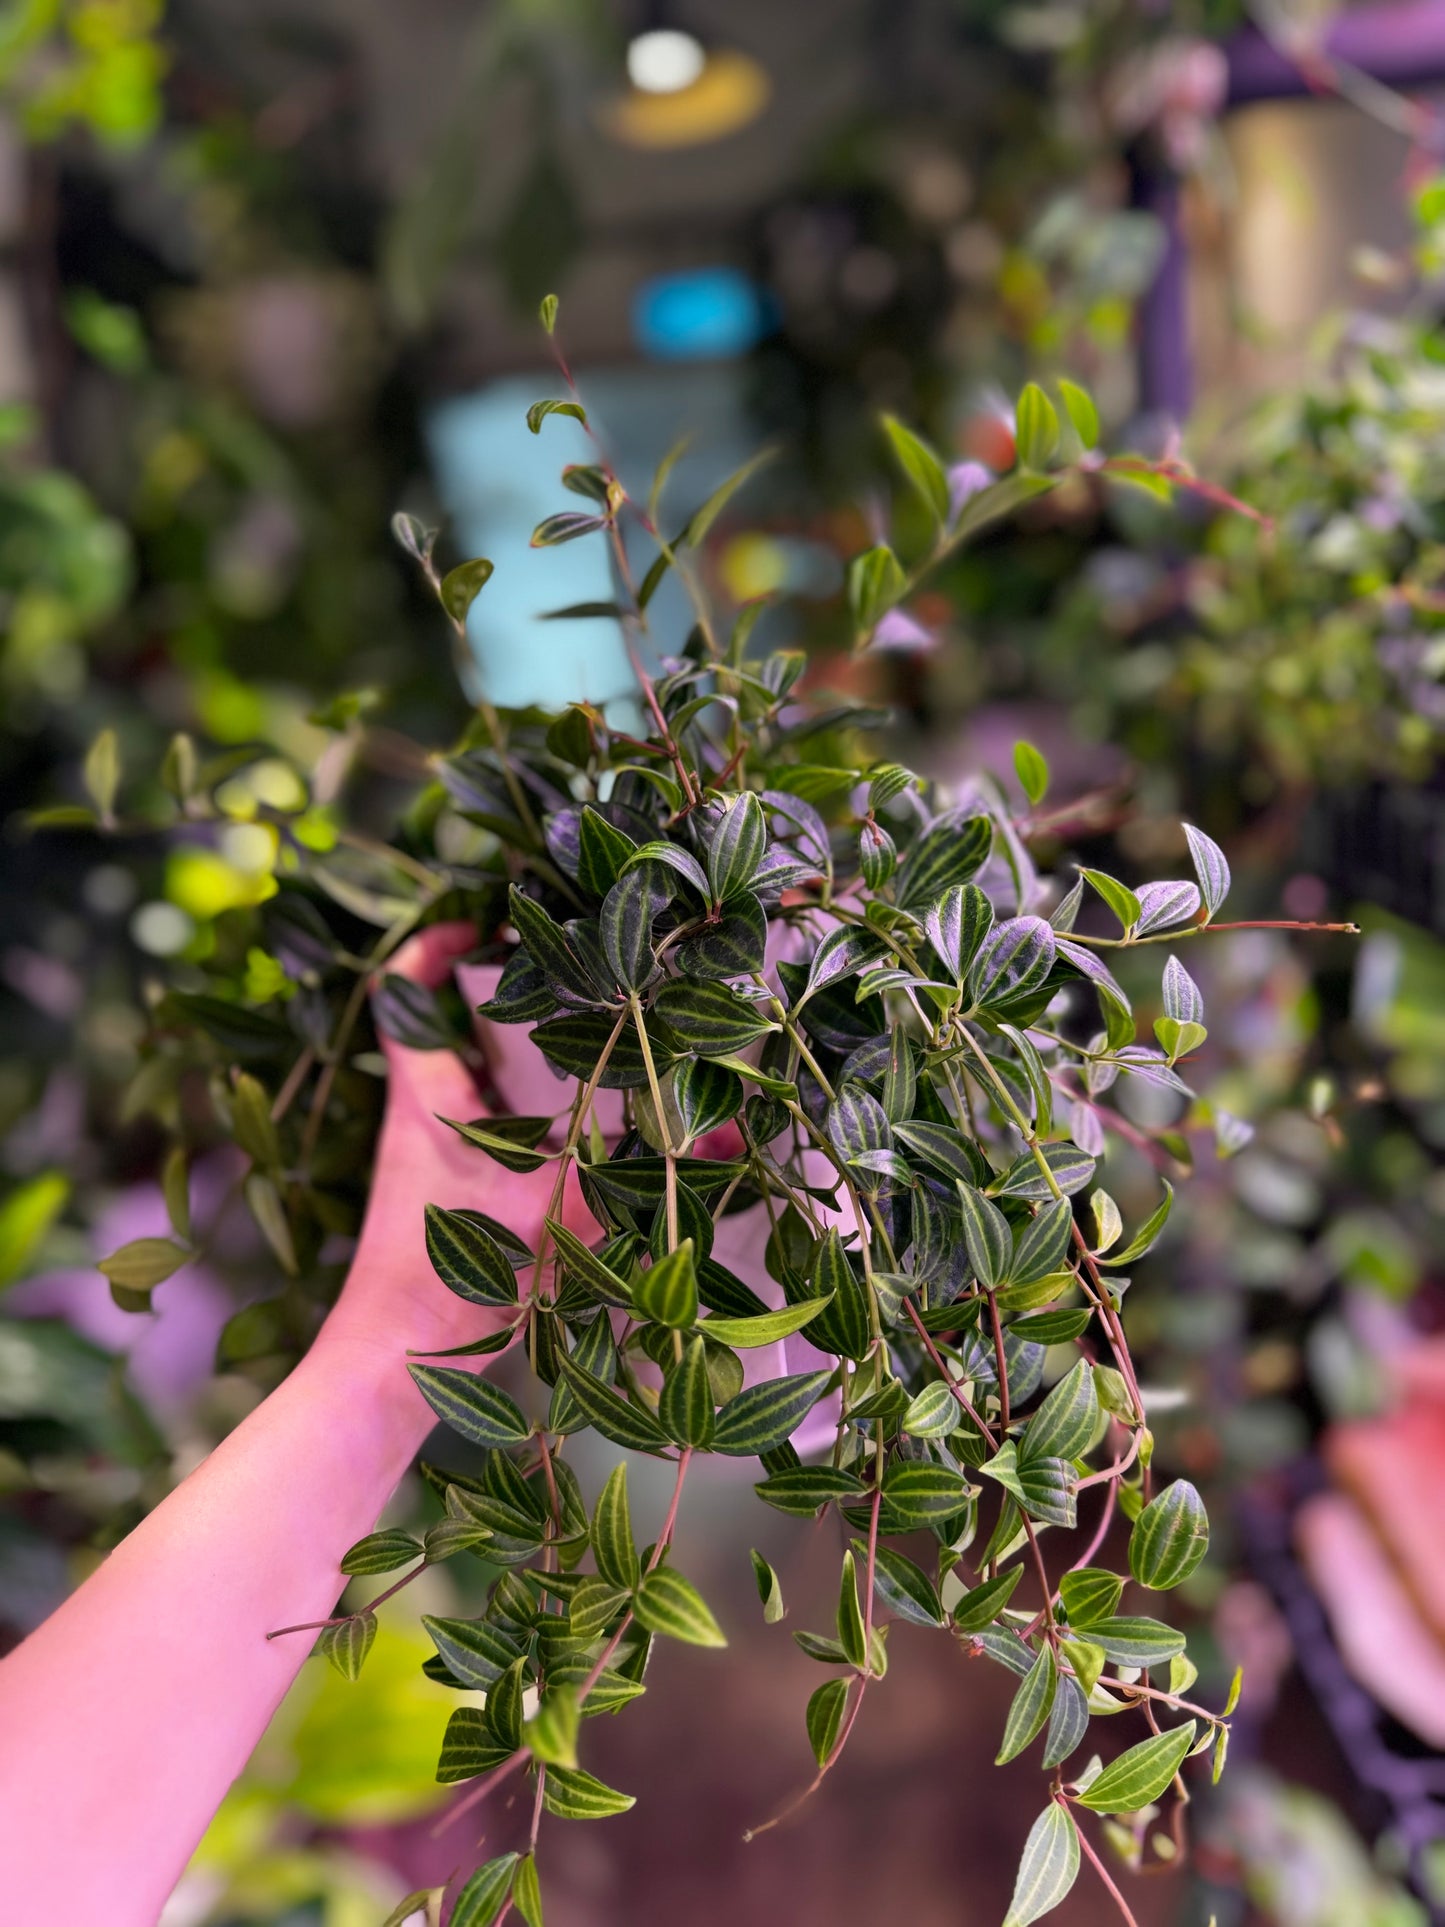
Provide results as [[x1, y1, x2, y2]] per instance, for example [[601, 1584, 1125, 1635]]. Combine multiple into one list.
[[92, 308, 1364, 1927]]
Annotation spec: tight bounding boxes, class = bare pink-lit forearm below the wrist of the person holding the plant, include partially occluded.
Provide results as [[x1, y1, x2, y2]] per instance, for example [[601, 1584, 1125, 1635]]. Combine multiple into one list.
[[0, 1332, 432, 1927]]
